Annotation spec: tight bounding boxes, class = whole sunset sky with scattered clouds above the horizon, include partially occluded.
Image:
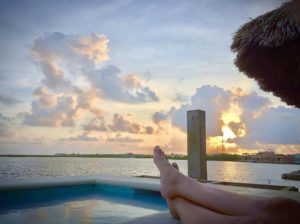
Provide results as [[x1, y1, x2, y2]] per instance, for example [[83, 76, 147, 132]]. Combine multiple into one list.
[[0, 0, 300, 154]]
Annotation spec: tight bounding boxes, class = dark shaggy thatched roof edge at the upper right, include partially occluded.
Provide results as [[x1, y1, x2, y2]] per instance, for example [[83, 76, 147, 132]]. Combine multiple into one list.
[[231, 0, 300, 108]]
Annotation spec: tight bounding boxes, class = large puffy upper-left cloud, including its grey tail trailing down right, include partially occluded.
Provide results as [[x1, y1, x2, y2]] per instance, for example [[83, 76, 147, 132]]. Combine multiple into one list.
[[31, 32, 159, 103]]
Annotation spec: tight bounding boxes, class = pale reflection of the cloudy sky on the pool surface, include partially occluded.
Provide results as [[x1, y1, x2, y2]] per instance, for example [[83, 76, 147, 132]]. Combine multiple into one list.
[[0, 199, 167, 224]]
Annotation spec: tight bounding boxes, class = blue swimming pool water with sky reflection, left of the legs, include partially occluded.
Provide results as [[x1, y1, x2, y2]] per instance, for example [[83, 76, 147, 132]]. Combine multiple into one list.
[[0, 184, 167, 224]]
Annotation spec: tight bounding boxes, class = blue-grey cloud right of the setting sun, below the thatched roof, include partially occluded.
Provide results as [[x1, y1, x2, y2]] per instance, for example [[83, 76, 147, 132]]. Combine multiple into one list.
[[231, 106, 300, 148]]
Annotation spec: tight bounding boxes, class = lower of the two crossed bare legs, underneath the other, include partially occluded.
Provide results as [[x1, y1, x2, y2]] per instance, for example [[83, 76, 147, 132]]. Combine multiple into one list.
[[170, 197, 262, 224]]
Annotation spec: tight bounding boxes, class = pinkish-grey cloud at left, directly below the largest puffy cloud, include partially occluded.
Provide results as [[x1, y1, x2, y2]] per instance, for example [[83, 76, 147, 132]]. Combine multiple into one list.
[[22, 87, 104, 127]]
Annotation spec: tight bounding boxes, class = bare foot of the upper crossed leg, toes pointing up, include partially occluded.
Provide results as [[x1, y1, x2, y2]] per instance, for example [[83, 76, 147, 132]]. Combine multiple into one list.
[[153, 146, 179, 199]]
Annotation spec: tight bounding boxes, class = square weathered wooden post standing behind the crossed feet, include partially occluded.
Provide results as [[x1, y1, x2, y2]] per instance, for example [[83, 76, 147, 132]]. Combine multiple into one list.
[[187, 110, 207, 180]]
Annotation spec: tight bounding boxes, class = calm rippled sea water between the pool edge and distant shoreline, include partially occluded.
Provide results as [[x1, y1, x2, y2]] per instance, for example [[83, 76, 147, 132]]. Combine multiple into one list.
[[0, 157, 300, 189]]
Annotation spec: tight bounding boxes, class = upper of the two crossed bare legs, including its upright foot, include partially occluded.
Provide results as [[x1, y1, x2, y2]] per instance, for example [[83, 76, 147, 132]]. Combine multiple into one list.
[[154, 147, 299, 220]]
